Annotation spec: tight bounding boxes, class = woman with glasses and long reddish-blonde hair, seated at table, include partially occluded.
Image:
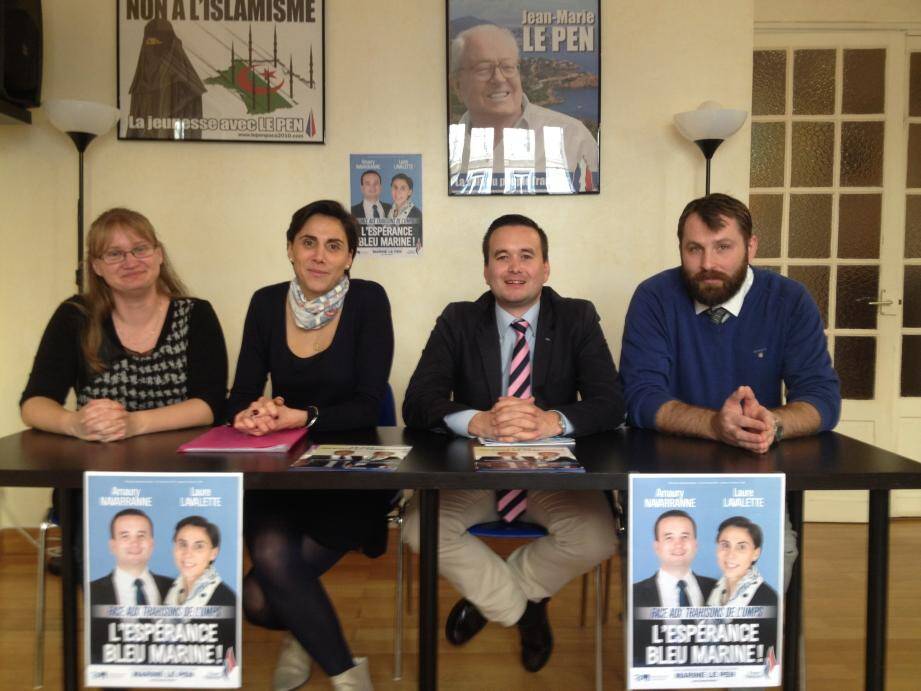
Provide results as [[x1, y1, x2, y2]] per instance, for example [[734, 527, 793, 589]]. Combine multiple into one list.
[[20, 208, 227, 442]]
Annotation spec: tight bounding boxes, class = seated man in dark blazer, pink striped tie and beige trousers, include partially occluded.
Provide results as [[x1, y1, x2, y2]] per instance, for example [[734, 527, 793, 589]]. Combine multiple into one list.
[[403, 214, 624, 672]]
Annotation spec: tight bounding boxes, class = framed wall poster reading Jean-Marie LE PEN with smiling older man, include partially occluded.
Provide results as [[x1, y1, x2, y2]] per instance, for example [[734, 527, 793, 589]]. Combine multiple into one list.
[[447, 0, 601, 195]]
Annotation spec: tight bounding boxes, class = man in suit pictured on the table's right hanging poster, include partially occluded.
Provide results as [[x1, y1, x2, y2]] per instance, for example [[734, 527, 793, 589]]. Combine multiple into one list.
[[633, 509, 716, 666]]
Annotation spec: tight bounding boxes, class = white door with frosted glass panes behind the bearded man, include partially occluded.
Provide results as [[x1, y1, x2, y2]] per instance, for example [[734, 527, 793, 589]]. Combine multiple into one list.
[[750, 30, 921, 521]]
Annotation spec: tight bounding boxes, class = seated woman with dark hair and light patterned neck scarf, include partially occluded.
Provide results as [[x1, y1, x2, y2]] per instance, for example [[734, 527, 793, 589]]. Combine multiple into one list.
[[228, 200, 393, 691]]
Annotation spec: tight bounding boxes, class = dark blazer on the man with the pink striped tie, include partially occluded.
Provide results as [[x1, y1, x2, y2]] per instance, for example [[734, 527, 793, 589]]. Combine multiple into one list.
[[403, 286, 624, 435]]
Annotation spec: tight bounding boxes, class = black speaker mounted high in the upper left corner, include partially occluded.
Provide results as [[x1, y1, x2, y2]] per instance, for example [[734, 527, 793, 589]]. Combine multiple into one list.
[[0, 0, 42, 108]]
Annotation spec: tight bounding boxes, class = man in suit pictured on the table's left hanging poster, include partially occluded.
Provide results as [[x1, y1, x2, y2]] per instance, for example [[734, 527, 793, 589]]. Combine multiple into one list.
[[90, 509, 173, 663]]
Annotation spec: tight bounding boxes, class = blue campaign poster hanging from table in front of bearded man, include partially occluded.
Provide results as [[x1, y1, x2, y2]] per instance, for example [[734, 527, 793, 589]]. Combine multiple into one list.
[[626, 474, 785, 689]]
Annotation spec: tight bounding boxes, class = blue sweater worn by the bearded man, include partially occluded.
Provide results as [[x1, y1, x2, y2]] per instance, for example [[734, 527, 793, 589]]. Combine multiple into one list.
[[620, 267, 841, 431]]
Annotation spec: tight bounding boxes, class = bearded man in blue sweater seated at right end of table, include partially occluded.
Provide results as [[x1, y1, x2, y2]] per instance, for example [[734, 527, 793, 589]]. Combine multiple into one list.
[[620, 194, 841, 596]]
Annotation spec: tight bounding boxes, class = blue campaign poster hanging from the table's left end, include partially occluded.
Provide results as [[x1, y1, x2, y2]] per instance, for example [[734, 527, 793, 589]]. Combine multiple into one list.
[[83, 472, 243, 688]]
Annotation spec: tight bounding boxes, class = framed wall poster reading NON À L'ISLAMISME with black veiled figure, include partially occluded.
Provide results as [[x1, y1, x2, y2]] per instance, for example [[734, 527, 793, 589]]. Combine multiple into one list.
[[118, 0, 325, 143]]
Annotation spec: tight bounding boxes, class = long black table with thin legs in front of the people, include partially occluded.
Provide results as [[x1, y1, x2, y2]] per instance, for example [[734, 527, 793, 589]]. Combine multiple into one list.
[[0, 428, 921, 689]]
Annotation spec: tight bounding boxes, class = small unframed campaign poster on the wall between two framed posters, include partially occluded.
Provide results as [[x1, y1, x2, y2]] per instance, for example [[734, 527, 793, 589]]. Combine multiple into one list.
[[349, 154, 422, 257]]
